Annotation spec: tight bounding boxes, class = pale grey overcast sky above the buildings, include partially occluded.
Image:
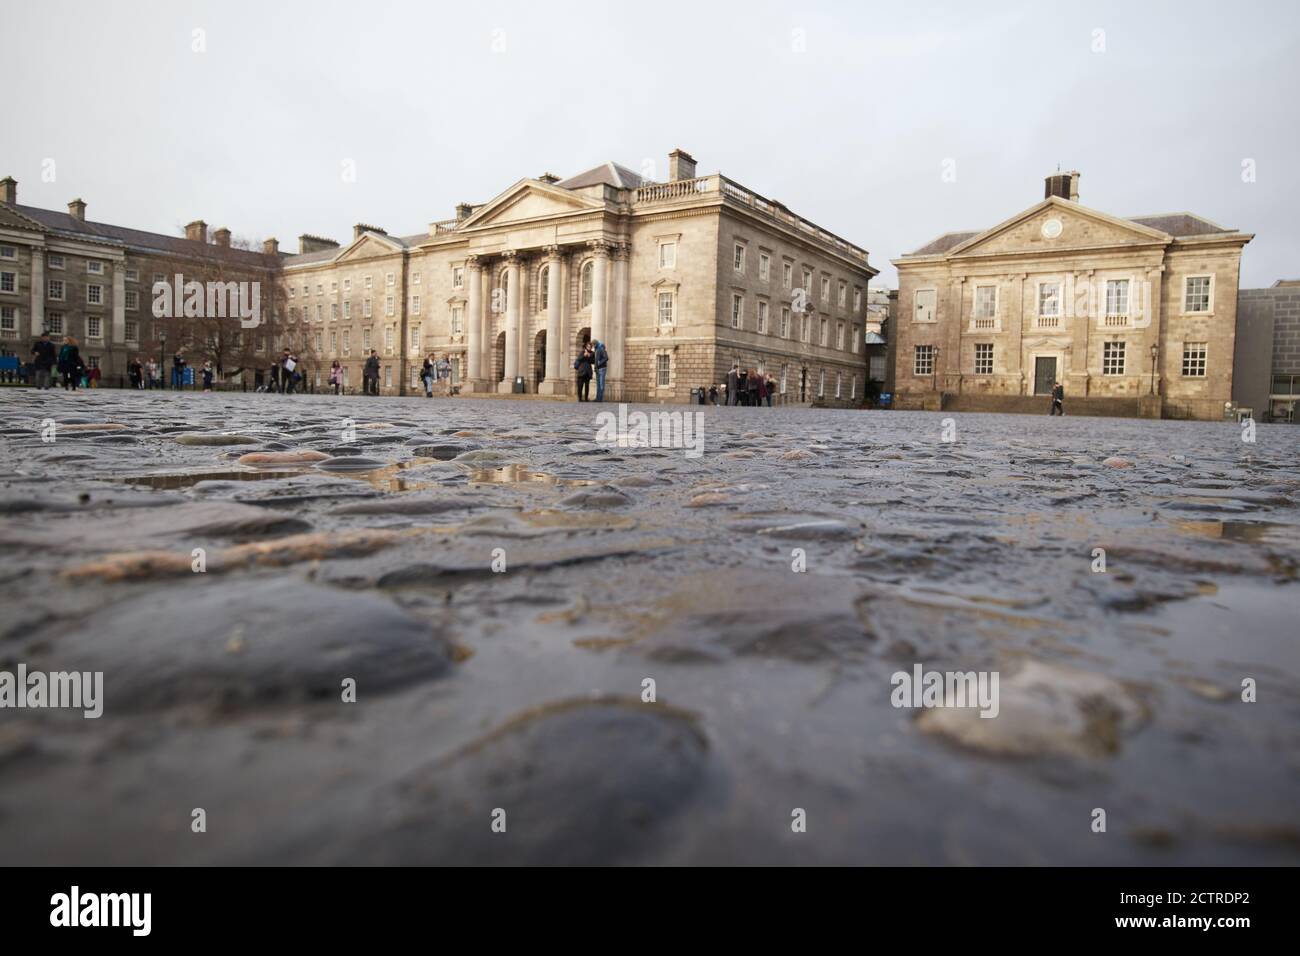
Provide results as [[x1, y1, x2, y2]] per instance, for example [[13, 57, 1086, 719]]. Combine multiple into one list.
[[0, 0, 1300, 286]]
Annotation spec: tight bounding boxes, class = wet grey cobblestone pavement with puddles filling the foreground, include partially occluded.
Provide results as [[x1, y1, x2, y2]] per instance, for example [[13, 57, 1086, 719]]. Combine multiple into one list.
[[0, 389, 1300, 864]]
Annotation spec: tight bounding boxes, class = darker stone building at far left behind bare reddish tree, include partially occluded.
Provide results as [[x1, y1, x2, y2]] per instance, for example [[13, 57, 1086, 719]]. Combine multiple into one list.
[[0, 177, 280, 384]]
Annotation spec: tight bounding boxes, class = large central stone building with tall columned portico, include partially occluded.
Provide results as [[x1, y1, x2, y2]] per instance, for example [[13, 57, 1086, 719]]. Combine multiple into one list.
[[282, 150, 876, 406]]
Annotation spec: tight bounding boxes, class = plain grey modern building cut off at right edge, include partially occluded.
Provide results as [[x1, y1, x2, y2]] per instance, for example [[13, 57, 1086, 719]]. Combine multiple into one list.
[[1232, 278, 1300, 421]]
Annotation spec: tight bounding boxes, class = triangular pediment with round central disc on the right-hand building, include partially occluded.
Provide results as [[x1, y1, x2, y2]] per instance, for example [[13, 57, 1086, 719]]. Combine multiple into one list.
[[948, 196, 1173, 258]]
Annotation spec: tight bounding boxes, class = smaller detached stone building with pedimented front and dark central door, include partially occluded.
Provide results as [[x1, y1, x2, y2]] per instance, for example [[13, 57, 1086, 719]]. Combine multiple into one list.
[[894, 172, 1253, 419]]
